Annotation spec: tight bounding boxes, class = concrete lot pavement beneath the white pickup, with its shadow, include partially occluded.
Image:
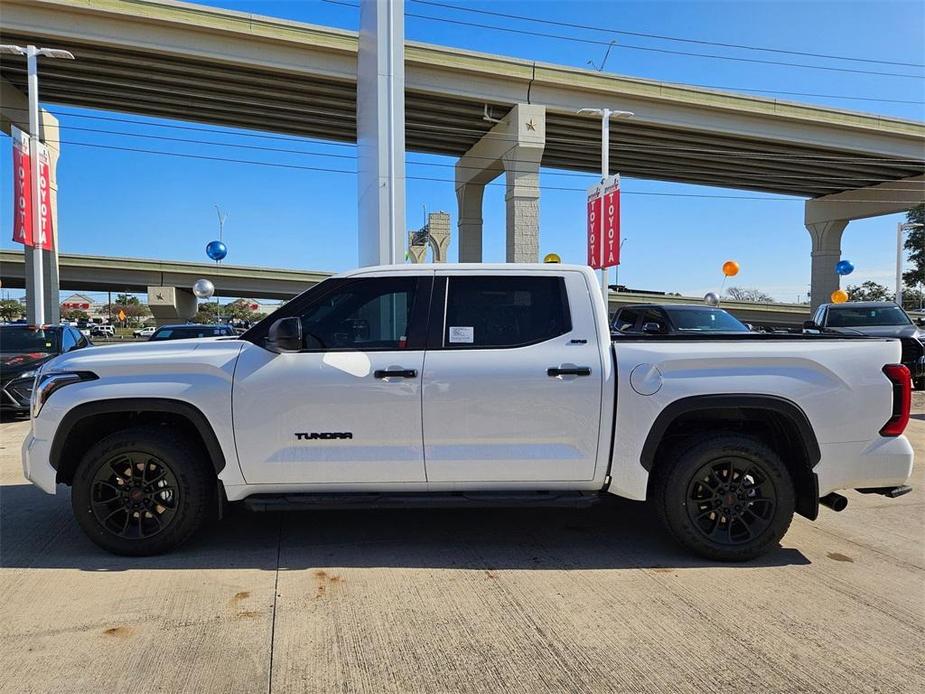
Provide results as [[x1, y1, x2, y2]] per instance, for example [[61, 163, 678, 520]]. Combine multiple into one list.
[[0, 394, 925, 694]]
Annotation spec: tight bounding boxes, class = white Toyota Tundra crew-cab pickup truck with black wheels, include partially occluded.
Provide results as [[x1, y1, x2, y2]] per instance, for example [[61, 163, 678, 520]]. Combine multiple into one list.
[[22, 264, 913, 560]]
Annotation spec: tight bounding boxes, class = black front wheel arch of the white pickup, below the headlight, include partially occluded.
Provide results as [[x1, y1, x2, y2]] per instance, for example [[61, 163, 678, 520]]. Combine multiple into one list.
[[51, 404, 225, 484]]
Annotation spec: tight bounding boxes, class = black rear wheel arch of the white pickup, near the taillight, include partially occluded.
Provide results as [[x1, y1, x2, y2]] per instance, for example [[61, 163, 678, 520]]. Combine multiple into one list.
[[643, 406, 819, 520]]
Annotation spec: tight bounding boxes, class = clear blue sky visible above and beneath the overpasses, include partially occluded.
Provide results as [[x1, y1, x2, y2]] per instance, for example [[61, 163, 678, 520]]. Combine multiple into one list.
[[0, 0, 925, 301]]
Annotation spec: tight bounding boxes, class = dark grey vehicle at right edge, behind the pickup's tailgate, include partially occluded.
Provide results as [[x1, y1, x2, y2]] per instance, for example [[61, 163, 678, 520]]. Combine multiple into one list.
[[803, 301, 925, 389]]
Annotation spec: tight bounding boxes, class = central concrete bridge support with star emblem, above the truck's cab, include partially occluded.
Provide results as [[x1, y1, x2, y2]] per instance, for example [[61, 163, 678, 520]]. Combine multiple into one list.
[[456, 104, 546, 262]]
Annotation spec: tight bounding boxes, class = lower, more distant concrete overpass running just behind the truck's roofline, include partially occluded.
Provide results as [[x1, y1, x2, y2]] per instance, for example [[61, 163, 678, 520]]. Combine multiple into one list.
[[0, 250, 810, 327]]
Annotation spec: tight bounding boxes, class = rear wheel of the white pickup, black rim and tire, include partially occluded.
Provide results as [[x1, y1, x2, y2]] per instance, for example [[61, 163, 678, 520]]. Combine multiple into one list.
[[653, 433, 796, 561]]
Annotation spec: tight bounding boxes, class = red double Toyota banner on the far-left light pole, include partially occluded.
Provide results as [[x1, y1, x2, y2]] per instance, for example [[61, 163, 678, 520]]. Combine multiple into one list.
[[11, 126, 54, 250]]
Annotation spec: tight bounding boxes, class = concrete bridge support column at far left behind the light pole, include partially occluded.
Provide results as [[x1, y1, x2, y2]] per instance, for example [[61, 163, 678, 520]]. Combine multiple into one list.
[[0, 78, 61, 323]]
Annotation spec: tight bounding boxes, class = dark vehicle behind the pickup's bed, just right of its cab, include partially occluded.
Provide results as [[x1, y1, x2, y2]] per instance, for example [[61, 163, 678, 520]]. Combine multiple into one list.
[[611, 304, 749, 335]]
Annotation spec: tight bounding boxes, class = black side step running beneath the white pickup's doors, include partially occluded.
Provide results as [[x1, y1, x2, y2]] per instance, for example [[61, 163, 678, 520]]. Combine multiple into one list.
[[241, 491, 603, 511]]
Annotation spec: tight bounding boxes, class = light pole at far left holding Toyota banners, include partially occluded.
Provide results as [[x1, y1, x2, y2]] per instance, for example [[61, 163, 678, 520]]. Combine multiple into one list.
[[0, 44, 74, 325]]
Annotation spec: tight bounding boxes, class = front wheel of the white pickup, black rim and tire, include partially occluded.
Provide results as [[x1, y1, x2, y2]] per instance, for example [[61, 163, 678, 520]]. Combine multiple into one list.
[[71, 426, 216, 557]]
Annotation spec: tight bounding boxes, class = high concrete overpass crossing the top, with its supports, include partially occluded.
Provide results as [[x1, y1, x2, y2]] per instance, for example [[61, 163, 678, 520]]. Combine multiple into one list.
[[0, 0, 925, 310]]
